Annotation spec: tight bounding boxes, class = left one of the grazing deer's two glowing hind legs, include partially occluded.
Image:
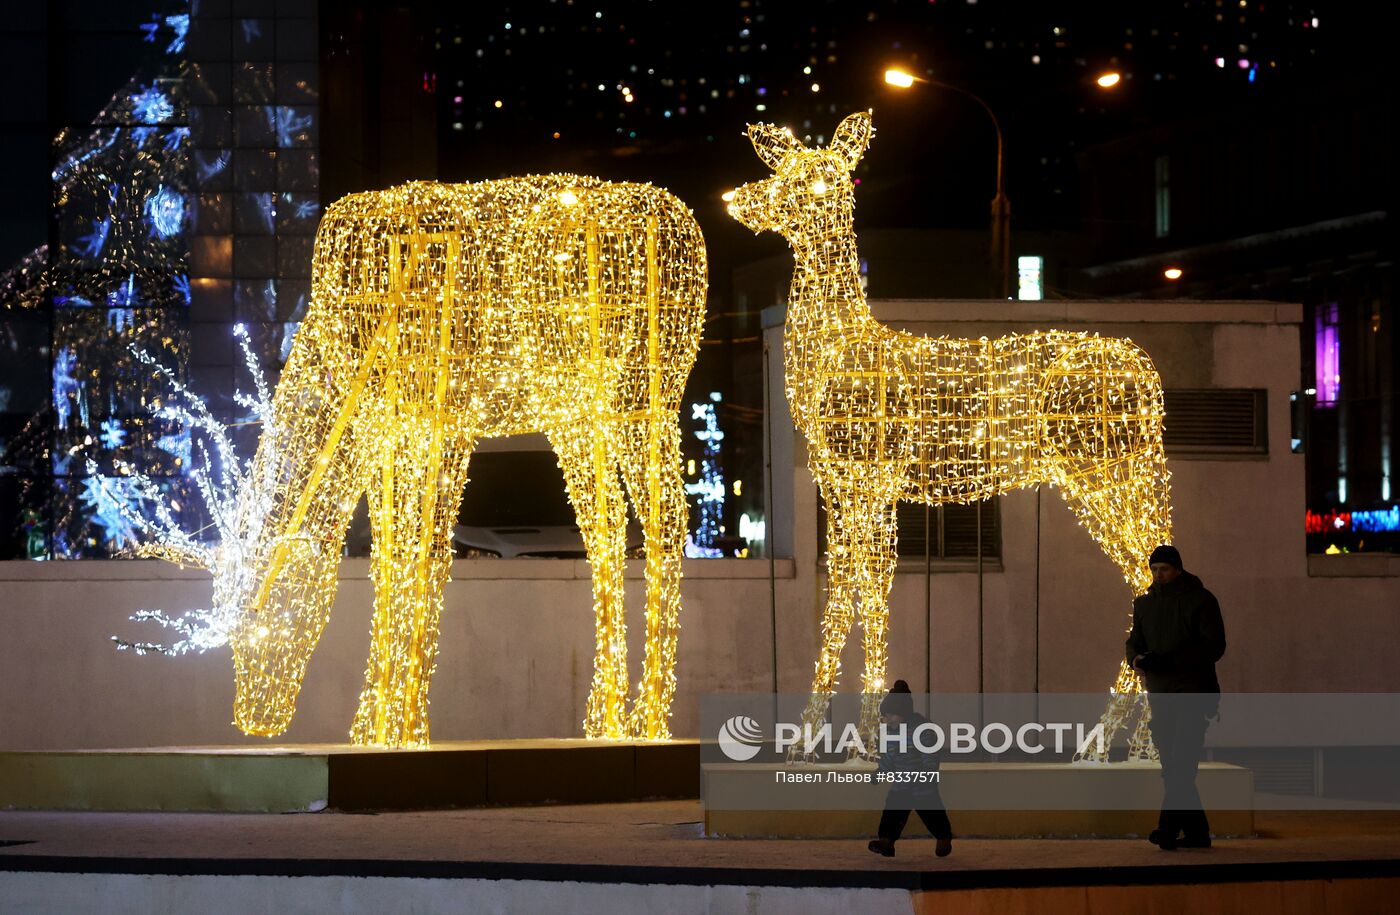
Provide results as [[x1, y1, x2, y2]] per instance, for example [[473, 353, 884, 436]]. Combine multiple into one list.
[[549, 424, 629, 740]]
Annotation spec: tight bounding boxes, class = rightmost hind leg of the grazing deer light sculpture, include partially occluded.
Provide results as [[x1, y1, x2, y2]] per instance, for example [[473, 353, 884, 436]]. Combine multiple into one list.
[[622, 411, 689, 740]]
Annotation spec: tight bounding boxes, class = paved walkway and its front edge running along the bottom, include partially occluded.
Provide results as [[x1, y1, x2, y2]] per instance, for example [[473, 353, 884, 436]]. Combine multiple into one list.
[[0, 800, 1400, 915]]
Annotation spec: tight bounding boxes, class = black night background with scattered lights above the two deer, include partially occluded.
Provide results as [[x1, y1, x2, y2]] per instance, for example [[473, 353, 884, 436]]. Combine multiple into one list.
[[422, 0, 1375, 281]]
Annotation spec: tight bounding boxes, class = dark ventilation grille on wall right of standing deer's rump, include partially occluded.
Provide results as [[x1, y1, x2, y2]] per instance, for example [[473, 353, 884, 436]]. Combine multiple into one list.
[[1162, 388, 1268, 458]]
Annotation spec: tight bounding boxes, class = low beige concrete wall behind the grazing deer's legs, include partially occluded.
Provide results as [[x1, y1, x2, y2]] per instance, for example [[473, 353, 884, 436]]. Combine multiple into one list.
[[0, 558, 812, 750]]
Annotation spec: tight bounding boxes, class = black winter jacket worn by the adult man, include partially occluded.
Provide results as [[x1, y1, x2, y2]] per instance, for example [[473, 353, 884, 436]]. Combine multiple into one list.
[[1126, 572, 1225, 693]]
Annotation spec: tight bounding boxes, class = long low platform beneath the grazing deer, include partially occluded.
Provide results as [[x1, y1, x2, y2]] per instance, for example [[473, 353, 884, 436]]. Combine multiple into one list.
[[0, 740, 700, 813]]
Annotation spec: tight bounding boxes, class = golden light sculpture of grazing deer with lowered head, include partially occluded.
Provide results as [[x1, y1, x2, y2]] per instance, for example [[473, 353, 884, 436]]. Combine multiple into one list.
[[170, 175, 706, 747]]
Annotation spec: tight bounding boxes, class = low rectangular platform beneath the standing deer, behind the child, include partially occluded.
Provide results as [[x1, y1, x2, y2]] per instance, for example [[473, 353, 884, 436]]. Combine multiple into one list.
[[701, 763, 1254, 838]]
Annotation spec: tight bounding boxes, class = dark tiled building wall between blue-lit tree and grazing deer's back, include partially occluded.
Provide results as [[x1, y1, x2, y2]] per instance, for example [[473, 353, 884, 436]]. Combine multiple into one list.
[[185, 0, 322, 413]]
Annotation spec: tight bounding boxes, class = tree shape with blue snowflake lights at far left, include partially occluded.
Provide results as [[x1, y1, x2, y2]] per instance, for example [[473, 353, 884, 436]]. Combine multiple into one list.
[[0, 8, 190, 557]]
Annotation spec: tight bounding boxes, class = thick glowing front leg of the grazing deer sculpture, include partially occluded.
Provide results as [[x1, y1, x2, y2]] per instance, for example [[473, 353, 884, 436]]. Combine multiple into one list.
[[350, 439, 470, 747]]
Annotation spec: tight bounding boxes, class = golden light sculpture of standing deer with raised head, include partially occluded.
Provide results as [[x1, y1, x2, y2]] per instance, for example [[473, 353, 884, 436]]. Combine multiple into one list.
[[729, 112, 1170, 758]]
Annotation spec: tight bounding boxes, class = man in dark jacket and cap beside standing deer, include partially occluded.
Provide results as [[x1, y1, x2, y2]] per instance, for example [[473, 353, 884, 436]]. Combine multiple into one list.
[[1127, 546, 1225, 851]]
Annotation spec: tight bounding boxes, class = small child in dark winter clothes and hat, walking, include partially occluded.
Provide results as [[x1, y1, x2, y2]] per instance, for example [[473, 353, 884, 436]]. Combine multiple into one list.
[[869, 680, 953, 858]]
